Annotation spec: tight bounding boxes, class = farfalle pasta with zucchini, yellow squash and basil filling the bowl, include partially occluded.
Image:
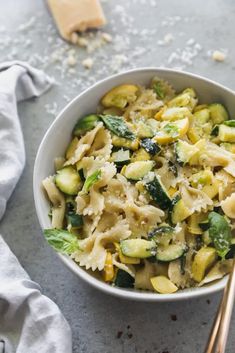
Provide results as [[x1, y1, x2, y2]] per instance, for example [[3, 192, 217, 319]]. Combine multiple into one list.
[[43, 77, 235, 294]]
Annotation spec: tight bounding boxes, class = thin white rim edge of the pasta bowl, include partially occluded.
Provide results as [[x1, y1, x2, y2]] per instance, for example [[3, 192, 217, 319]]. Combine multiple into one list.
[[33, 67, 235, 302]]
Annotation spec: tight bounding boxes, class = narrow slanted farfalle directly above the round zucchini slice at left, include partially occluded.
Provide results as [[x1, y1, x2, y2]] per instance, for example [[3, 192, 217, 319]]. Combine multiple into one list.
[[64, 122, 103, 166]]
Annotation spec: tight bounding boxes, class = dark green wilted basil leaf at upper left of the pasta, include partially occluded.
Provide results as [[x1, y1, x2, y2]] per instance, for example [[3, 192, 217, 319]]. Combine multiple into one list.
[[100, 115, 135, 140]]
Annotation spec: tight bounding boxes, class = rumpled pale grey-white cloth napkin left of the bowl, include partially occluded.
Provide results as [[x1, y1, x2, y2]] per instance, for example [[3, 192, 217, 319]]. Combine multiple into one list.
[[0, 61, 72, 353]]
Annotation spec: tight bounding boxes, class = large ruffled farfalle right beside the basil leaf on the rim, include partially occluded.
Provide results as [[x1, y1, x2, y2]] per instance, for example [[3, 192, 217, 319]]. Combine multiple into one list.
[[73, 220, 131, 271]]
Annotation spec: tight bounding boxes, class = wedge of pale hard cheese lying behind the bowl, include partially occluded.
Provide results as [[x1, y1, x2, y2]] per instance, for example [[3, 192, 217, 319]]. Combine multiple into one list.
[[47, 0, 106, 43]]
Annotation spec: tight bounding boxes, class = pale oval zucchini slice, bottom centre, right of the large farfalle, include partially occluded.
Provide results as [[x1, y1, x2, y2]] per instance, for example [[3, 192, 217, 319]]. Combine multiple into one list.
[[120, 239, 156, 259]]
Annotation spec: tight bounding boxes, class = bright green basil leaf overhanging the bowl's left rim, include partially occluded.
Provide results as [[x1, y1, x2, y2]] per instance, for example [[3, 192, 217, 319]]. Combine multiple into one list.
[[44, 229, 79, 255]]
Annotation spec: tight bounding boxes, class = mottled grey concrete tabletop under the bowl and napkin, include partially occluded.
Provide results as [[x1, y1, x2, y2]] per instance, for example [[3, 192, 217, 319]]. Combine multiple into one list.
[[0, 0, 235, 353]]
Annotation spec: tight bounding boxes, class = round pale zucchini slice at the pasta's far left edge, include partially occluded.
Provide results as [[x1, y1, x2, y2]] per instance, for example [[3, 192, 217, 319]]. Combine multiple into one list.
[[55, 166, 82, 195]]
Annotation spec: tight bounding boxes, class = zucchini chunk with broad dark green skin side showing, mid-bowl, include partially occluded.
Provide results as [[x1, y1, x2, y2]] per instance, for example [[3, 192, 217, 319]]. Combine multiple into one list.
[[145, 172, 171, 210]]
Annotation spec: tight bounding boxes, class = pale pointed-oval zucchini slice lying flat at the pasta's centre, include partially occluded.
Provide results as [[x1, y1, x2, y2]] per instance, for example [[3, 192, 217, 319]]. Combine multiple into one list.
[[121, 161, 154, 180]]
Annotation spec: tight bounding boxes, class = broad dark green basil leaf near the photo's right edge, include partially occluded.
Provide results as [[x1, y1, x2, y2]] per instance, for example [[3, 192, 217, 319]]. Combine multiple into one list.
[[208, 212, 232, 258]]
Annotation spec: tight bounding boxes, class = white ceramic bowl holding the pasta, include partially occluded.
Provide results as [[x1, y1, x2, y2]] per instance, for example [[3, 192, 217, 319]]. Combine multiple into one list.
[[33, 68, 235, 302]]
